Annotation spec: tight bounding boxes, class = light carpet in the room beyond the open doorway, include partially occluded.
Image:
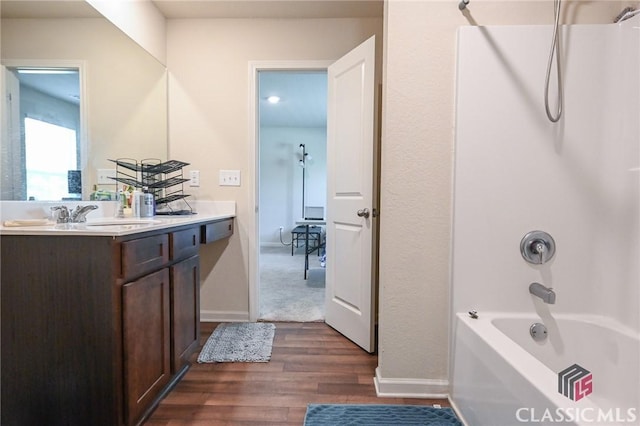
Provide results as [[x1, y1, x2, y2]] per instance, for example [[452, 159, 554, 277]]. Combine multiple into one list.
[[259, 246, 325, 322]]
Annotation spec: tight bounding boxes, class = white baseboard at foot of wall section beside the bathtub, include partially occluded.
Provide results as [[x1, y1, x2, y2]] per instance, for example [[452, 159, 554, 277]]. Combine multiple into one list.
[[373, 368, 449, 399]]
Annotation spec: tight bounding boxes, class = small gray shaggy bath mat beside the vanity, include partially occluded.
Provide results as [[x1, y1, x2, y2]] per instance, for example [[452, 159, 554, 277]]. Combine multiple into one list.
[[198, 322, 276, 363]]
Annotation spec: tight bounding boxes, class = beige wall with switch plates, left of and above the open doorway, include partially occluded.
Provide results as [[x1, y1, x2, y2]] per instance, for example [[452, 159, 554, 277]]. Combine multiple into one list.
[[167, 18, 382, 320]]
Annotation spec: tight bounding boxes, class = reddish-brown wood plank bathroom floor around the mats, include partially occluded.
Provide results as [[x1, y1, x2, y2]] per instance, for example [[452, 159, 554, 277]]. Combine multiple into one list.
[[145, 322, 449, 426]]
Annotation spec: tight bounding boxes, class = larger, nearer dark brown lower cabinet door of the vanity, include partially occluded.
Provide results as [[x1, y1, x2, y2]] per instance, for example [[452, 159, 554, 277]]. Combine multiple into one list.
[[122, 268, 171, 425]]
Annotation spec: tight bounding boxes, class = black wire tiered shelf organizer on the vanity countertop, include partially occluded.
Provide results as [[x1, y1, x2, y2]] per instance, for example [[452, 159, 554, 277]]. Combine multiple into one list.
[[109, 158, 193, 215]]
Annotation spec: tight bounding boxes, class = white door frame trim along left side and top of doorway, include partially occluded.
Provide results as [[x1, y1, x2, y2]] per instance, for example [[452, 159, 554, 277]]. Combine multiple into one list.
[[247, 60, 334, 322]]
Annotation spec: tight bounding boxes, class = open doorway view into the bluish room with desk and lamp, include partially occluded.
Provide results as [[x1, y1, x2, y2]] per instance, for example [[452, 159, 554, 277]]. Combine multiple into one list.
[[256, 69, 327, 322]]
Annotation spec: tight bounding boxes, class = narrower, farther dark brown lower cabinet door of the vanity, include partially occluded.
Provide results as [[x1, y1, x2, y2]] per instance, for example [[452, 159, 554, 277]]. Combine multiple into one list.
[[171, 256, 200, 373]]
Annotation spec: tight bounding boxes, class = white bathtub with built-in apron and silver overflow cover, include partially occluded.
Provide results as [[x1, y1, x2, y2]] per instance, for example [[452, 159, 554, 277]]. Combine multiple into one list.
[[451, 312, 640, 426]]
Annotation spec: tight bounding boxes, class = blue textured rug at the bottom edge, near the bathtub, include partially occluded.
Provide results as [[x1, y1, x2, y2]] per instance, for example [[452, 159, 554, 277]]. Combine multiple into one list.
[[304, 404, 462, 426]]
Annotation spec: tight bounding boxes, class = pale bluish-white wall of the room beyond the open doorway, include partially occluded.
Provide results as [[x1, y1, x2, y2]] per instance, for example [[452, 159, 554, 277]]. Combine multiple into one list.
[[260, 127, 327, 246]]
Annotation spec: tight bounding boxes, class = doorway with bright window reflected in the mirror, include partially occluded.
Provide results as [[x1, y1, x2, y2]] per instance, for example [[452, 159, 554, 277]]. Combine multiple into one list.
[[0, 60, 86, 200]]
